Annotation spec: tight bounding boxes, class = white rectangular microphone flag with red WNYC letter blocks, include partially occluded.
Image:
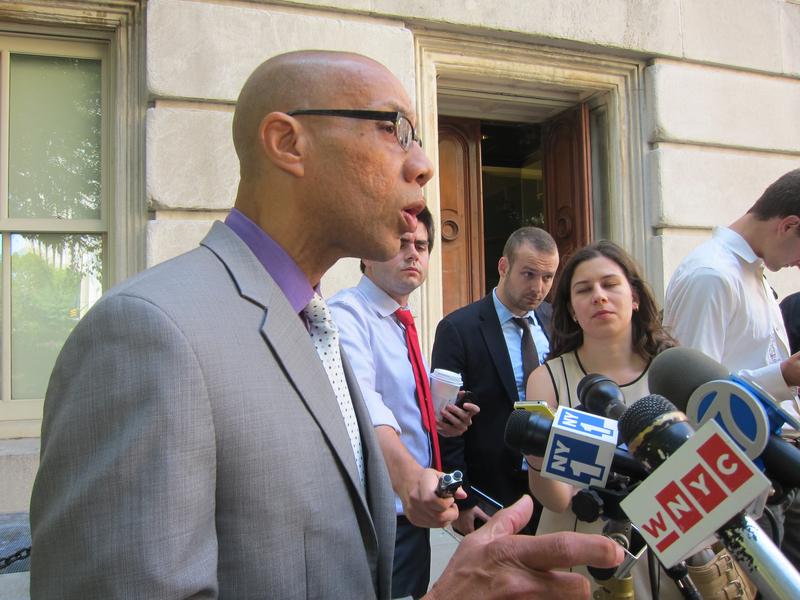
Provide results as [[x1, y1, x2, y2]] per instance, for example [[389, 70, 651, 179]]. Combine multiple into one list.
[[620, 419, 770, 568]]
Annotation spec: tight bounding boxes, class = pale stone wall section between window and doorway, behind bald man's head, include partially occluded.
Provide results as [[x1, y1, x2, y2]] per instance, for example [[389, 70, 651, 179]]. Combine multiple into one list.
[[147, 0, 414, 294]]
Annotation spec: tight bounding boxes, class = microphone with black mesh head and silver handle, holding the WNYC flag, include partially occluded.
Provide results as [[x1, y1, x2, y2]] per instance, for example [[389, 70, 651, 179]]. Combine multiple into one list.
[[619, 394, 800, 600]]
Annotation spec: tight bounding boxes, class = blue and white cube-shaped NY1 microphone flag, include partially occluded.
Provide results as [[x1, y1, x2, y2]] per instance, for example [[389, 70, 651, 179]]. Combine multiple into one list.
[[542, 406, 618, 488]]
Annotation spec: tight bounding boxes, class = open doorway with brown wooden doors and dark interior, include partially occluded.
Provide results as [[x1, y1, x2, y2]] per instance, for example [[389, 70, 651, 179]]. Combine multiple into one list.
[[439, 104, 593, 314]]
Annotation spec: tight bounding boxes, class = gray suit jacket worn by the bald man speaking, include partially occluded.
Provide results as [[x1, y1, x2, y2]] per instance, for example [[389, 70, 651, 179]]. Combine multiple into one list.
[[31, 223, 395, 600]]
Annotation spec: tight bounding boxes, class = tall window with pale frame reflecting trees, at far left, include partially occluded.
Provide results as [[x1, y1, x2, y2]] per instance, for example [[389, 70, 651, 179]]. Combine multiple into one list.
[[0, 35, 112, 420]]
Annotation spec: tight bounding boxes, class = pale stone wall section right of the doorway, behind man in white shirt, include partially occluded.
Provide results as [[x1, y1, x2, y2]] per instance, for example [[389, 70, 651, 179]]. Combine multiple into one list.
[[645, 59, 800, 296]]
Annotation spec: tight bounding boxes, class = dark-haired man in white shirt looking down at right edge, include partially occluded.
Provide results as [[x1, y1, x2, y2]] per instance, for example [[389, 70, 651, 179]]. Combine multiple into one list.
[[664, 169, 800, 564]]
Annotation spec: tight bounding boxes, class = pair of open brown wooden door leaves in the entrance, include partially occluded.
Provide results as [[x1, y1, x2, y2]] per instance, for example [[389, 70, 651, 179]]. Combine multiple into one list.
[[439, 104, 592, 314]]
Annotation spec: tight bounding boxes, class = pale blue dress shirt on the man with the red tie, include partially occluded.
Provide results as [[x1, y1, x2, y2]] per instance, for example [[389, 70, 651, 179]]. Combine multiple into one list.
[[328, 276, 431, 514]]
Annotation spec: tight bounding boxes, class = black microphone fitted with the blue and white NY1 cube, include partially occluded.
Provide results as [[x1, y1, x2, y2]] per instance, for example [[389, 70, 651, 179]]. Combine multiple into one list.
[[504, 407, 647, 487]]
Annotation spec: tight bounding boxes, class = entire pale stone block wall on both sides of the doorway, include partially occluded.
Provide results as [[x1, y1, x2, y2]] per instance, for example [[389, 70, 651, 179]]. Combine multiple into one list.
[[146, 0, 800, 295]]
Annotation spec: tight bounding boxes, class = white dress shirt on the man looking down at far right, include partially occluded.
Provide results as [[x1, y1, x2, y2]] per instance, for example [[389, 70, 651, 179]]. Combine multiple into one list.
[[664, 227, 796, 401]]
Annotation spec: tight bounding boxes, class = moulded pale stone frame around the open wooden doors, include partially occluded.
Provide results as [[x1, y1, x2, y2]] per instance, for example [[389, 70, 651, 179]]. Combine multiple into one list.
[[414, 30, 644, 352]]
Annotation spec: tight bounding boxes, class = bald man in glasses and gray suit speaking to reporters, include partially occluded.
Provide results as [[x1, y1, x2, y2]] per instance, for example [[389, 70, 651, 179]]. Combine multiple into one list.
[[31, 51, 621, 600]]
